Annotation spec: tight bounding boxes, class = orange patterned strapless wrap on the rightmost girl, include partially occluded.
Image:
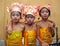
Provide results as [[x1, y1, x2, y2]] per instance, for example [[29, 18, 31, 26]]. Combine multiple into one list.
[[40, 28, 52, 44]]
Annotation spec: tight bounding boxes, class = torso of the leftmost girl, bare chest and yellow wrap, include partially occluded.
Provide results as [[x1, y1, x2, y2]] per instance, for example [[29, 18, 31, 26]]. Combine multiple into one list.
[[6, 25, 23, 46]]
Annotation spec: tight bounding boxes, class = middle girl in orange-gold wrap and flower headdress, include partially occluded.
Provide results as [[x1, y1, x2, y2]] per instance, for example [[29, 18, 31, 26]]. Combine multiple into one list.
[[24, 7, 39, 46]]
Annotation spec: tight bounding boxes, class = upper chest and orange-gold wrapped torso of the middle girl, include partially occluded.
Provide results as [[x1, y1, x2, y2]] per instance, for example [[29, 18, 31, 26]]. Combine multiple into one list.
[[24, 25, 36, 46]]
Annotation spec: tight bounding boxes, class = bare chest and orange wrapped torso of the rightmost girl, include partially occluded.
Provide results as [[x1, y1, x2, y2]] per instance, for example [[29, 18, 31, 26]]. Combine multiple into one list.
[[39, 22, 52, 43]]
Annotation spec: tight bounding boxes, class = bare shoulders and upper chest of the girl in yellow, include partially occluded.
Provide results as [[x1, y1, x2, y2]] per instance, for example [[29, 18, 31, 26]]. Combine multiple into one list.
[[6, 23, 24, 33]]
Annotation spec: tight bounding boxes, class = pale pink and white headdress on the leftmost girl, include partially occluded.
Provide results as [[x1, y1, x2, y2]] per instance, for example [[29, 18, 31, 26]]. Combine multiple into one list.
[[7, 3, 23, 12]]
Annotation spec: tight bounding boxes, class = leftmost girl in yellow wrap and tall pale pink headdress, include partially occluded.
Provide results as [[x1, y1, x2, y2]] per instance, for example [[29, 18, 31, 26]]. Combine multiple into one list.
[[6, 3, 24, 46]]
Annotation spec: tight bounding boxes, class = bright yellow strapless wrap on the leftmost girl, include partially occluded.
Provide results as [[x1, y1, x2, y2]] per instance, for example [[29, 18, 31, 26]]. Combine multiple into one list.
[[6, 30, 22, 46]]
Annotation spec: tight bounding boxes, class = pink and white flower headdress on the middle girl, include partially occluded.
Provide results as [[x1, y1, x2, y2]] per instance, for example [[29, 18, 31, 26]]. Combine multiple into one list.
[[24, 5, 40, 16]]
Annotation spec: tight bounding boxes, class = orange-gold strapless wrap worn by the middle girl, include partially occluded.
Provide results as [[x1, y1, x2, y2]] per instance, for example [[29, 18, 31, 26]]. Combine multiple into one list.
[[24, 30, 36, 46]]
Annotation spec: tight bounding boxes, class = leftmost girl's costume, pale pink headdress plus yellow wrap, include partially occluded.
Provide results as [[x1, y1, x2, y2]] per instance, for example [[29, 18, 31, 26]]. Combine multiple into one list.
[[6, 3, 23, 46]]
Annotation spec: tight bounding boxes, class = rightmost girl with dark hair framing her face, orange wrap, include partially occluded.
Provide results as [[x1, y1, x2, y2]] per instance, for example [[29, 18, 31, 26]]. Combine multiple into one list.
[[37, 7, 55, 46]]
